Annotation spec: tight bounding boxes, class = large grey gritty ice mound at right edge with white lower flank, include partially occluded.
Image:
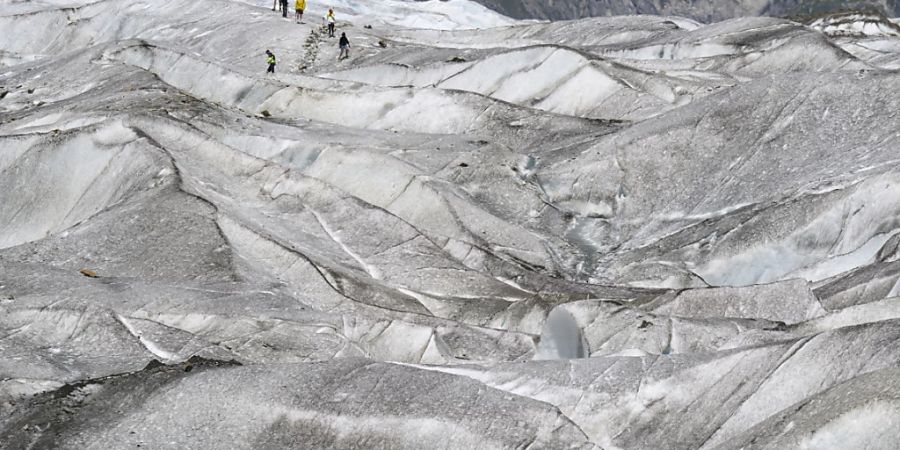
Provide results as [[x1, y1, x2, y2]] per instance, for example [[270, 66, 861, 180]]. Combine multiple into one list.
[[540, 72, 900, 284]]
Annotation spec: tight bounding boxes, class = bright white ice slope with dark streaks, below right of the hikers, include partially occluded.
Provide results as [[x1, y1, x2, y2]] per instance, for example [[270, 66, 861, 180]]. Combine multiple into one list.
[[323, 46, 698, 120]]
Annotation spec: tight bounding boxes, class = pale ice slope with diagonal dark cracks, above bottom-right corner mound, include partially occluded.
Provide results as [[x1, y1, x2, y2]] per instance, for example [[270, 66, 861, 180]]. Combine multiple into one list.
[[427, 321, 897, 448]]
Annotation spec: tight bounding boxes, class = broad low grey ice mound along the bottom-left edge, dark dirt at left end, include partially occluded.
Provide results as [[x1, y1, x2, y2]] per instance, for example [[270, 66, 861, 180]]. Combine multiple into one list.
[[3, 358, 597, 449]]
